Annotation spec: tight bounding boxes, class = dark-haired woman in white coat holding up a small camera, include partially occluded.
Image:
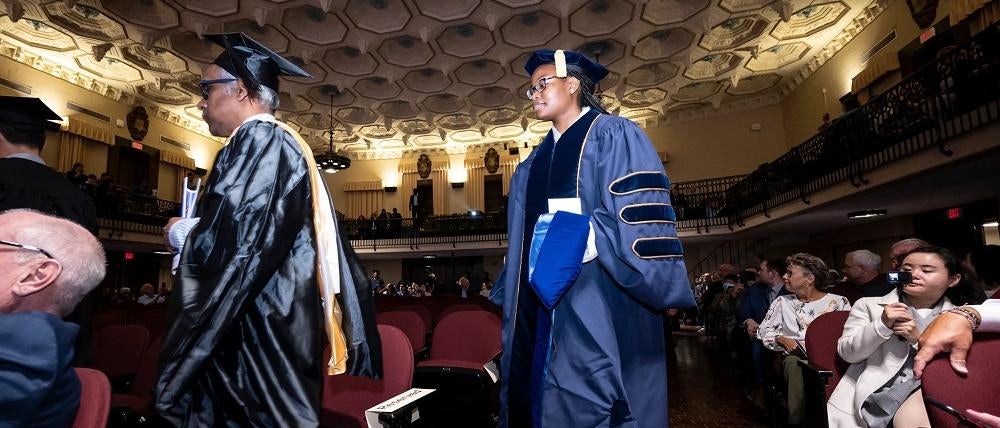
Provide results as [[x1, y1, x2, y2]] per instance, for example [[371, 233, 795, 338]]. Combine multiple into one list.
[[827, 247, 980, 428]]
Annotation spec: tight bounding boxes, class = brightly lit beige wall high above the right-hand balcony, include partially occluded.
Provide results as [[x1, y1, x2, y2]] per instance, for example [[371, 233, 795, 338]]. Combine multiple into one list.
[[781, 0, 924, 148]]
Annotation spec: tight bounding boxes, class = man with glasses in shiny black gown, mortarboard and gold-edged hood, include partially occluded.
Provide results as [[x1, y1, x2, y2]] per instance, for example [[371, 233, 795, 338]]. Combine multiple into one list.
[[156, 33, 380, 427]]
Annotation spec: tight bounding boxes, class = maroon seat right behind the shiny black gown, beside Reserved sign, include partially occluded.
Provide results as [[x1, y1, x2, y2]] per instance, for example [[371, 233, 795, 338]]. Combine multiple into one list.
[[320, 325, 413, 428]]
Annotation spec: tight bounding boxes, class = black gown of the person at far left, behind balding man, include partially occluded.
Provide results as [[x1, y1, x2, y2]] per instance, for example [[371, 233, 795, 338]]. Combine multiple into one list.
[[0, 158, 97, 367]]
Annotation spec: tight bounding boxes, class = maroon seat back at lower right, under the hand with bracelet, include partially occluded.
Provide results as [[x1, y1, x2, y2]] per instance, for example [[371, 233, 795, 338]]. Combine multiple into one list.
[[922, 333, 1000, 428]]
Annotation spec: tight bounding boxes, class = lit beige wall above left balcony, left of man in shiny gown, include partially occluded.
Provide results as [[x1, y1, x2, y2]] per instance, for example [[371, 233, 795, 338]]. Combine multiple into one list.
[[0, 56, 222, 184]]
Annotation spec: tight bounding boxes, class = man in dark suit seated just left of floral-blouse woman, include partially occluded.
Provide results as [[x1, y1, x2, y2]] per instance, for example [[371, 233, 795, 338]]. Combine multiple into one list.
[[733, 259, 788, 409]]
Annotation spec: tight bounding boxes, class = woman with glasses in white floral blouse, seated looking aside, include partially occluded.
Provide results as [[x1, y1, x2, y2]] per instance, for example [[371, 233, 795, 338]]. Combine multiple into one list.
[[757, 253, 851, 425]]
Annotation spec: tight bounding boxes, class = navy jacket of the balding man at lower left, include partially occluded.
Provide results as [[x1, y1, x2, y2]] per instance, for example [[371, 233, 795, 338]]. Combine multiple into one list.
[[0, 312, 80, 427]]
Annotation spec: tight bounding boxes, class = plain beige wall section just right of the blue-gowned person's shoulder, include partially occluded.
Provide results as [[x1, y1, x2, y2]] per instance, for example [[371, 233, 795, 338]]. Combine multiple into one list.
[[646, 105, 787, 182]]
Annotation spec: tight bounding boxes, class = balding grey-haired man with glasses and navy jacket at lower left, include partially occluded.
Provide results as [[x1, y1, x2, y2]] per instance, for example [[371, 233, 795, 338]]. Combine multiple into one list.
[[0, 210, 105, 427]]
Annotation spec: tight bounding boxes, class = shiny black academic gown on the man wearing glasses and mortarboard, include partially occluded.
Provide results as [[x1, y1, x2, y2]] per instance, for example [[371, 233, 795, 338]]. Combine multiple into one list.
[[156, 120, 381, 427]]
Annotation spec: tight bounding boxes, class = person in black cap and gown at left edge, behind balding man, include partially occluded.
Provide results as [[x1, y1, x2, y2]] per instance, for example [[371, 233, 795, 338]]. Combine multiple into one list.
[[0, 97, 97, 366]]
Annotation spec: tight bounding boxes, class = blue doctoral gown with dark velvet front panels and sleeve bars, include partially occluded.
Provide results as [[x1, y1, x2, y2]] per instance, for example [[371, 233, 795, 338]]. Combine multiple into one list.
[[493, 110, 695, 428]]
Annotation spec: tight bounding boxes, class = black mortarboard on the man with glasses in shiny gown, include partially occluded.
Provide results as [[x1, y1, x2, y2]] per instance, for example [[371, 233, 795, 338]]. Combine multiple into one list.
[[205, 33, 312, 95]]
